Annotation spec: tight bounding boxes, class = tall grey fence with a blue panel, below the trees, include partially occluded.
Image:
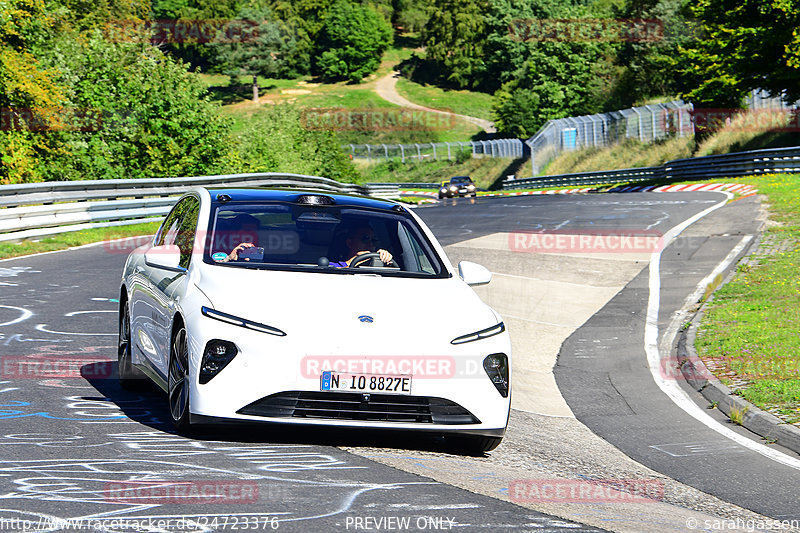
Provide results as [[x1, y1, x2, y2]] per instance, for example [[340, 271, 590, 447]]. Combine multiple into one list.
[[525, 100, 694, 176]]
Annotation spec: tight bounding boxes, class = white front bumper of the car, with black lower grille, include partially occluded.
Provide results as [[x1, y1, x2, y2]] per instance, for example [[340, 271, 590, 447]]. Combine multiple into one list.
[[188, 317, 511, 436]]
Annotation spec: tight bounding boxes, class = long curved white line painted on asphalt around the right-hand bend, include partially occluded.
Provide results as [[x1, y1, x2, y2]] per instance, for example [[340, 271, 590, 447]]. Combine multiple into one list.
[[644, 192, 800, 470]]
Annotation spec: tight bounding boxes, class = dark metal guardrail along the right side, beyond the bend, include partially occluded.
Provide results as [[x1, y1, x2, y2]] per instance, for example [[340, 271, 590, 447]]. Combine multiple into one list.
[[503, 146, 800, 189]]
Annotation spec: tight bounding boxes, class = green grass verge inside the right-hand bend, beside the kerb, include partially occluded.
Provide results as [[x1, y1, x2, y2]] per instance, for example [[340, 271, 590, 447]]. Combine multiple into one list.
[[695, 175, 800, 424]]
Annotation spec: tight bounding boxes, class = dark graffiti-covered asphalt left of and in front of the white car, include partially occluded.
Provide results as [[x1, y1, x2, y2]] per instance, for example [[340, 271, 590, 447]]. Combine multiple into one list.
[[0, 246, 593, 531]]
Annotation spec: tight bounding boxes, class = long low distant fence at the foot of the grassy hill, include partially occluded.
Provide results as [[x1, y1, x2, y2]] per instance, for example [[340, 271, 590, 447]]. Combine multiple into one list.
[[343, 139, 527, 163]]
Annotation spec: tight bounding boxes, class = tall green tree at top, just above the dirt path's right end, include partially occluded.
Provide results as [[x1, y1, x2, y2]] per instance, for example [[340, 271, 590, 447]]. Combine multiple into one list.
[[422, 0, 489, 89]]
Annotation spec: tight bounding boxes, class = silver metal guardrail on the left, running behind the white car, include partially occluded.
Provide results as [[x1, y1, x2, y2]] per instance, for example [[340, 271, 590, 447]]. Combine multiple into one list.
[[0, 172, 399, 242]]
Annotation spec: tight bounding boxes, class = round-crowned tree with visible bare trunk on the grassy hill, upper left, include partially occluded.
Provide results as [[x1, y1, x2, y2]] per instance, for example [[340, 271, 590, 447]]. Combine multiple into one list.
[[213, 8, 295, 102]]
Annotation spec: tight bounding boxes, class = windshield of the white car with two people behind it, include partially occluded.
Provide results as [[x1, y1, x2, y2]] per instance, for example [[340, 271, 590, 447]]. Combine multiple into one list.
[[204, 202, 449, 278]]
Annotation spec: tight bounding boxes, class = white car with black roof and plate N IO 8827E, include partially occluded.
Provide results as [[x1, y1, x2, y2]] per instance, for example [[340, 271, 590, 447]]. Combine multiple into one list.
[[118, 188, 511, 451]]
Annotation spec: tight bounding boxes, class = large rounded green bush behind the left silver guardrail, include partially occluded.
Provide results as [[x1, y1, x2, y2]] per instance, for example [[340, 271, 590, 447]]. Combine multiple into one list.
[[38, 33, 230, 180]]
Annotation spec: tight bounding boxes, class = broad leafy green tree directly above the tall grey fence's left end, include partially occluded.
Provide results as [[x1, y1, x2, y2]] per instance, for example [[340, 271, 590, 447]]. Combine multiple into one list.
[[485, 0, 619, 137]]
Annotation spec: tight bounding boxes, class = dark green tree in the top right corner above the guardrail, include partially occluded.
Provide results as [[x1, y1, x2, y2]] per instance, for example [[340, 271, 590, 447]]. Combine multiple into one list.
[[683, 0, 800, 107]]
